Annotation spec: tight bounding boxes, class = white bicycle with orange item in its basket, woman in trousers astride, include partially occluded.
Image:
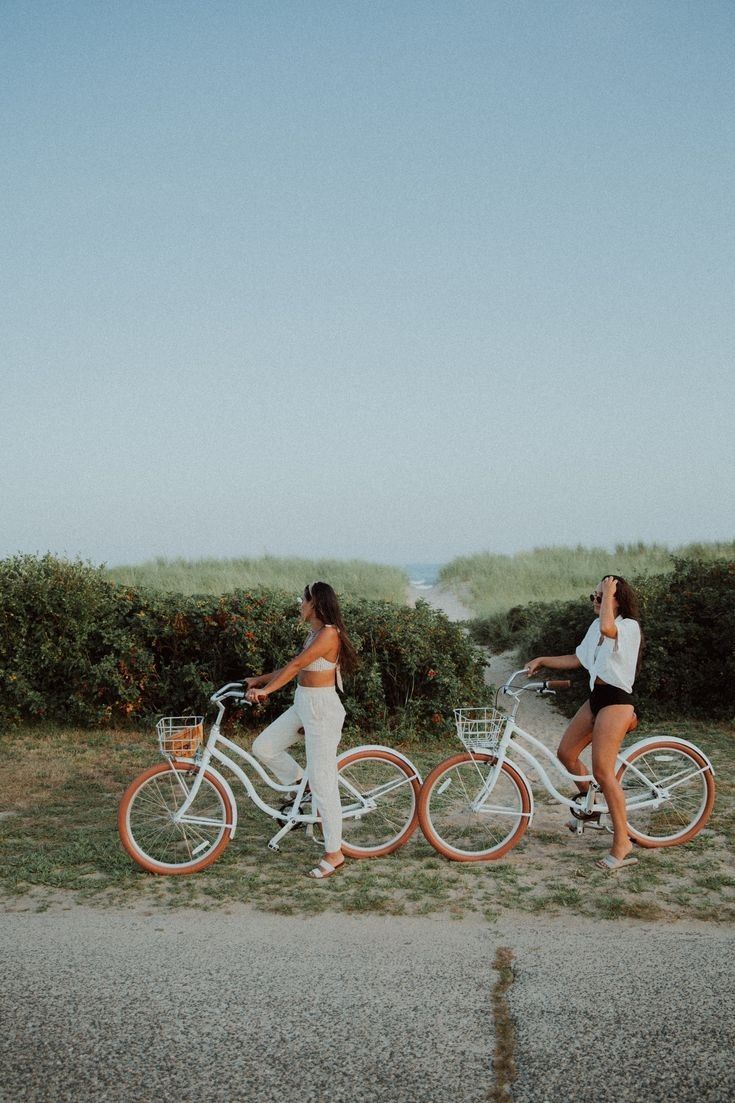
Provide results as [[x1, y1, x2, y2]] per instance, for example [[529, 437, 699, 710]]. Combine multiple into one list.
[[118, 682, 422, 874]]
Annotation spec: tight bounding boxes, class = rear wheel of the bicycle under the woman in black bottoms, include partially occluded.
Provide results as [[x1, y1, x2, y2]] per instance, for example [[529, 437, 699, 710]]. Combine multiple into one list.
[[617, 739, 715, 847]]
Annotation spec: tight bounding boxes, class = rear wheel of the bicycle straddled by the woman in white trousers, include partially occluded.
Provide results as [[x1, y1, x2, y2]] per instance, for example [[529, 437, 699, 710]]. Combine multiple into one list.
[[339, 747, 420, 858]]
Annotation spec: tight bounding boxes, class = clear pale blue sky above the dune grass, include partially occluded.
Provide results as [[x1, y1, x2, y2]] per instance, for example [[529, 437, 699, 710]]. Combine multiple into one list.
[[0, 0, 735, 564]]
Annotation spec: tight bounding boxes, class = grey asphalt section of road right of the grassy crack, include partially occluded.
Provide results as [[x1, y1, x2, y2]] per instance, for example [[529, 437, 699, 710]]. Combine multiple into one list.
[[509, 913, 735, 1103]]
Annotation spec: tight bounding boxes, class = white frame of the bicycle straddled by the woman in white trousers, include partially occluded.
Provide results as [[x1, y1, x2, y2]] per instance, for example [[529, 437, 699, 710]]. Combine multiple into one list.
[[165, 683, 420, 850]]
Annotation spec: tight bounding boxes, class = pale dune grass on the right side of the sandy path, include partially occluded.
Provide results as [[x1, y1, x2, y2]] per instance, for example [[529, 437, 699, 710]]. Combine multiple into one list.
[[439, 542, 735, 617]]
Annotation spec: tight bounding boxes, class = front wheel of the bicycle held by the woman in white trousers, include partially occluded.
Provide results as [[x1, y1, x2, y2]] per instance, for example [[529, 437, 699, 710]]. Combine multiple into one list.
[[117, 762, 234, 876]]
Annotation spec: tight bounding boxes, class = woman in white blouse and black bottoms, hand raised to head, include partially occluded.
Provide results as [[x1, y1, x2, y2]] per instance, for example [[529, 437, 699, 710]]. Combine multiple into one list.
[[525, 575, 641, 872]]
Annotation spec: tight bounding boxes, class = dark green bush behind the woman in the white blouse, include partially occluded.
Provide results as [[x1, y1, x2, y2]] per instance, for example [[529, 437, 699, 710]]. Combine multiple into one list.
[[515, 559, 735, 719]]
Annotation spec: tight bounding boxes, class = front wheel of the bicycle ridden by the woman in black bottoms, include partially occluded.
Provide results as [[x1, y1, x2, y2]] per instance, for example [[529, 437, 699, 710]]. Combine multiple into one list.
[[418, 751, 533, 861]]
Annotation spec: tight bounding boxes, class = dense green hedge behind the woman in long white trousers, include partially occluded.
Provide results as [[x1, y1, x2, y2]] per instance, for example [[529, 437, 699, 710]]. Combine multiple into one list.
[[0, 556, 486, 737]]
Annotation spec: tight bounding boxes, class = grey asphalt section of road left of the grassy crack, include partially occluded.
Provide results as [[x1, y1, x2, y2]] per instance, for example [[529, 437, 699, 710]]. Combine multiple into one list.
[[0, 904, 494, 1103]]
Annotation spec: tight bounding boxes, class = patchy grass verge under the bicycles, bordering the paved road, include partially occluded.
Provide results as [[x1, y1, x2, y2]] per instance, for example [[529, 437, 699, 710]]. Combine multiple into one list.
[[0, 722, 735, 922]]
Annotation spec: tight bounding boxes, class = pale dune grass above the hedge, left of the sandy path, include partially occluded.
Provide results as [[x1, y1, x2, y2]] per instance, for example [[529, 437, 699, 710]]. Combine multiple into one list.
[[107, 555, 408, 604]]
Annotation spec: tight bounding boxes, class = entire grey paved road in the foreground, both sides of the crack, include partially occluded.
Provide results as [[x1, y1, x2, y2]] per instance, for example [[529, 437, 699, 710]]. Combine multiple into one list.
[[0, 907, 735, 1103]]
